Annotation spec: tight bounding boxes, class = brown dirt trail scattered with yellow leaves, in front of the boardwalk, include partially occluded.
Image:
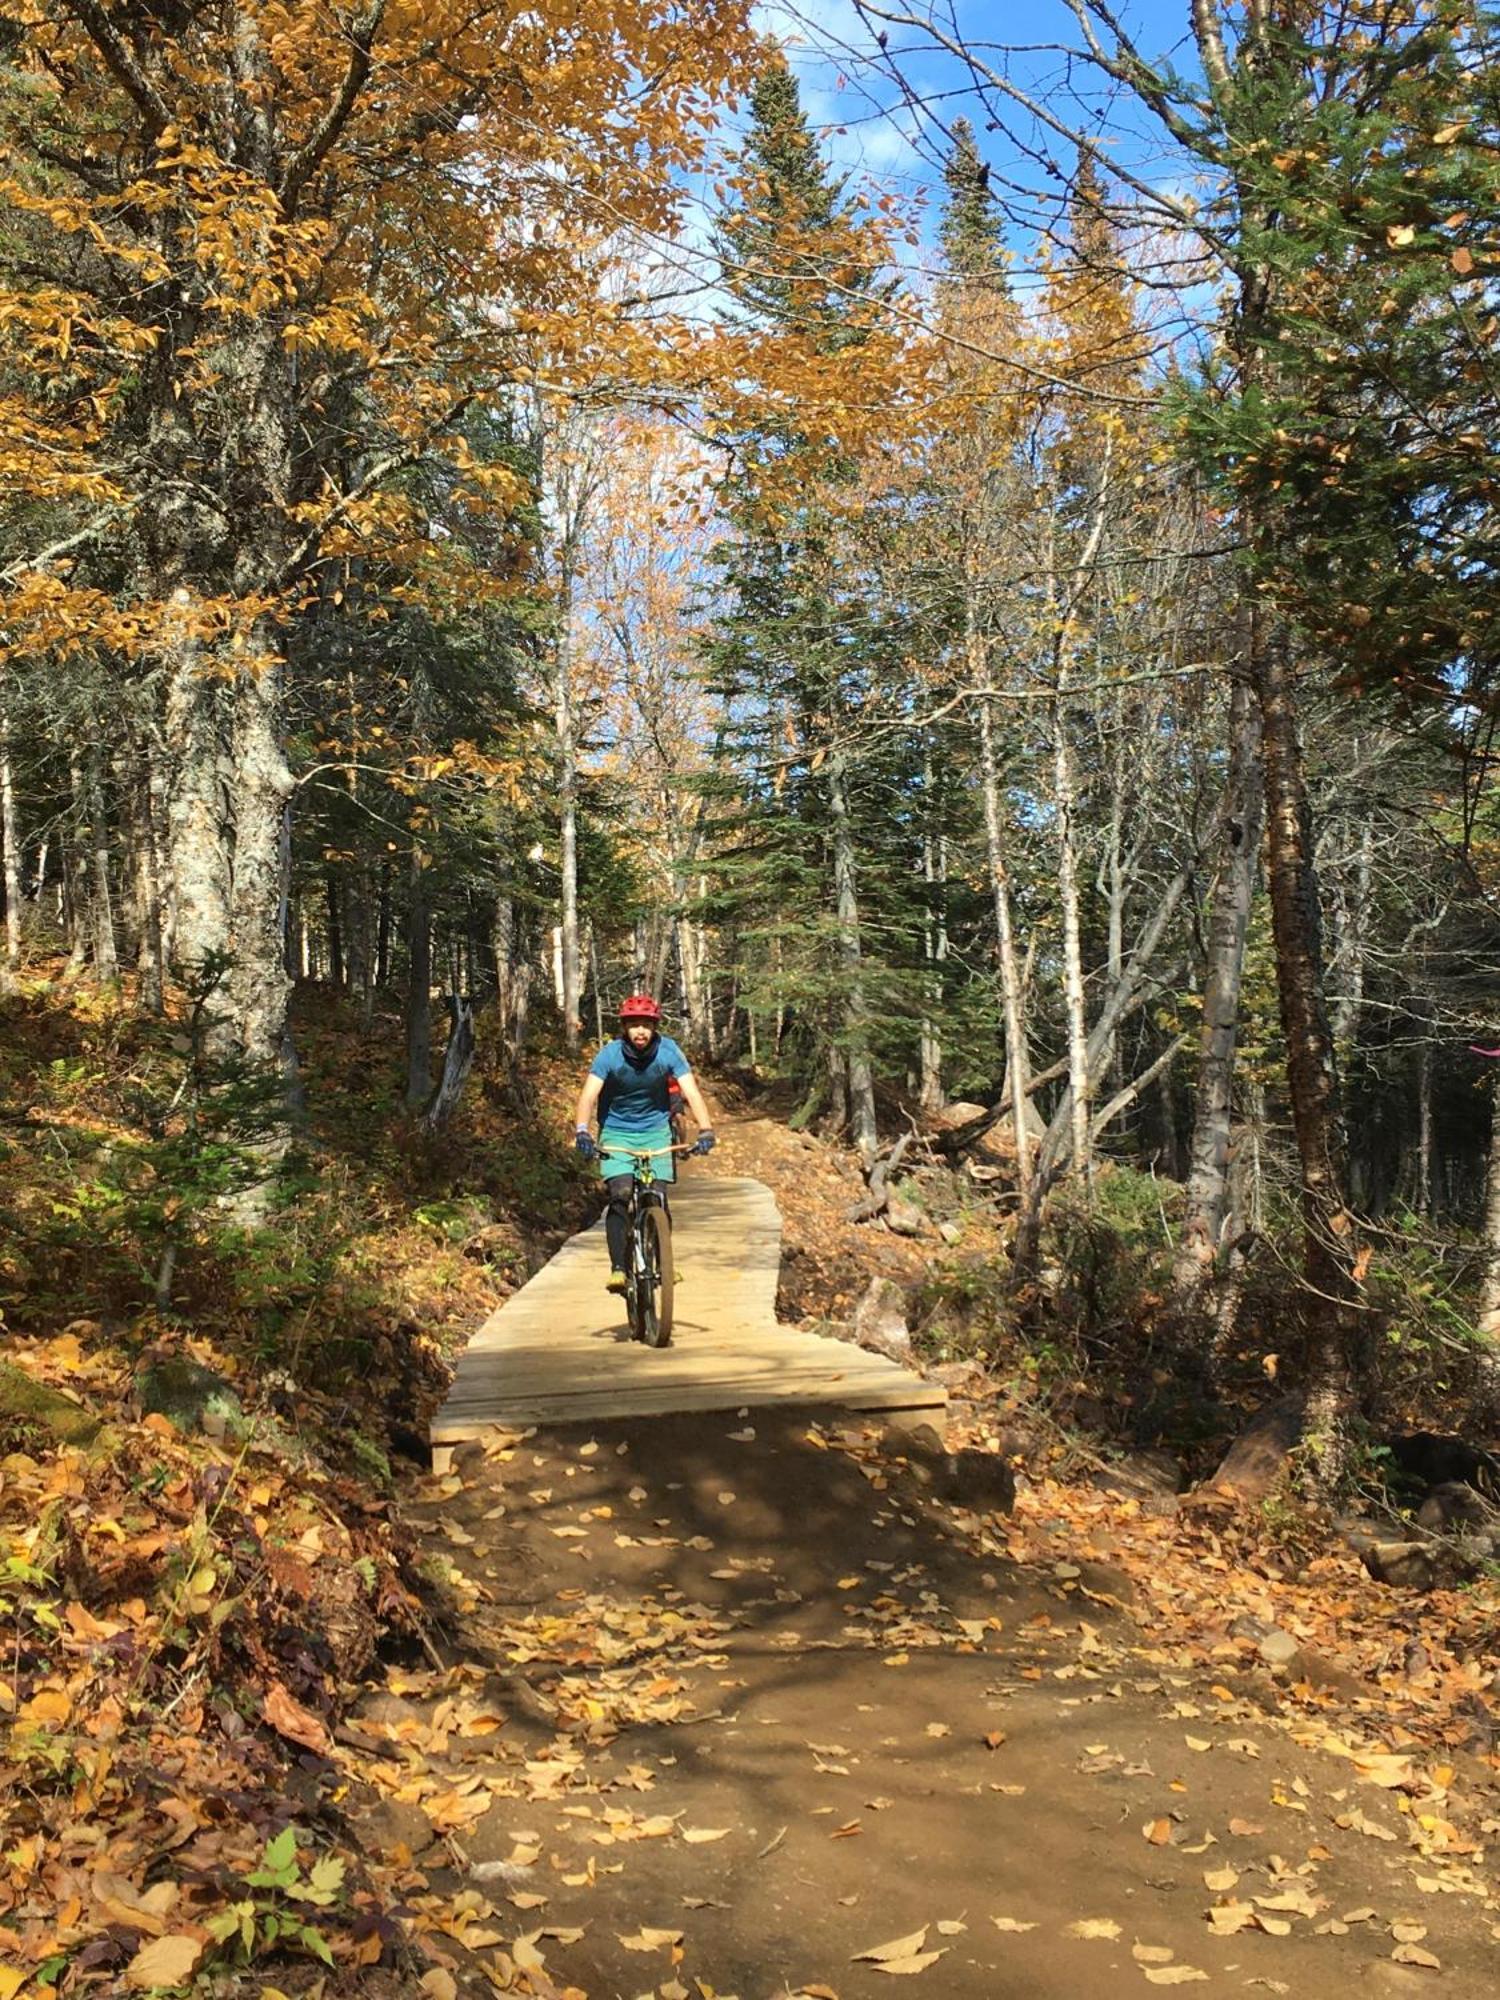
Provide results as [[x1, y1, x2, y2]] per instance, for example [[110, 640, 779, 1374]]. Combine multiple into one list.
[[382, 1412, 1500, 2000]]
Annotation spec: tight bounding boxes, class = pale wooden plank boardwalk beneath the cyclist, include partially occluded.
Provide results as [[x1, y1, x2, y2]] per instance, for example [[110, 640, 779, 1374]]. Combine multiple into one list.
[[432, 1172, 946, 1456]]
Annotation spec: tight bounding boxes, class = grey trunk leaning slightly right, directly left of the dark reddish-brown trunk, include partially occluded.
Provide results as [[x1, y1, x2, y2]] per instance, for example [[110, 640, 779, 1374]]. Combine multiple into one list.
[[1172, 678, 1264, 1306]]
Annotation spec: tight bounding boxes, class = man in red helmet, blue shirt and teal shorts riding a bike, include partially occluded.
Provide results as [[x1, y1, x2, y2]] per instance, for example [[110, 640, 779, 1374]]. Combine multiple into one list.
[[574, 994, 716, 1292]]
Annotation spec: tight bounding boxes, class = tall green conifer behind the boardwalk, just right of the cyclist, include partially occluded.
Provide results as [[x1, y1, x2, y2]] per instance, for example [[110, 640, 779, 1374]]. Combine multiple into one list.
[[708, 56, 912, 1158]]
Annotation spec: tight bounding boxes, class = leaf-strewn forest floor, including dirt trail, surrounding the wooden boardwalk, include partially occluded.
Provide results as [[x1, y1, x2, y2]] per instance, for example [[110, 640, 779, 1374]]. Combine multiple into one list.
[[0, 990, 1500, 2000]]
